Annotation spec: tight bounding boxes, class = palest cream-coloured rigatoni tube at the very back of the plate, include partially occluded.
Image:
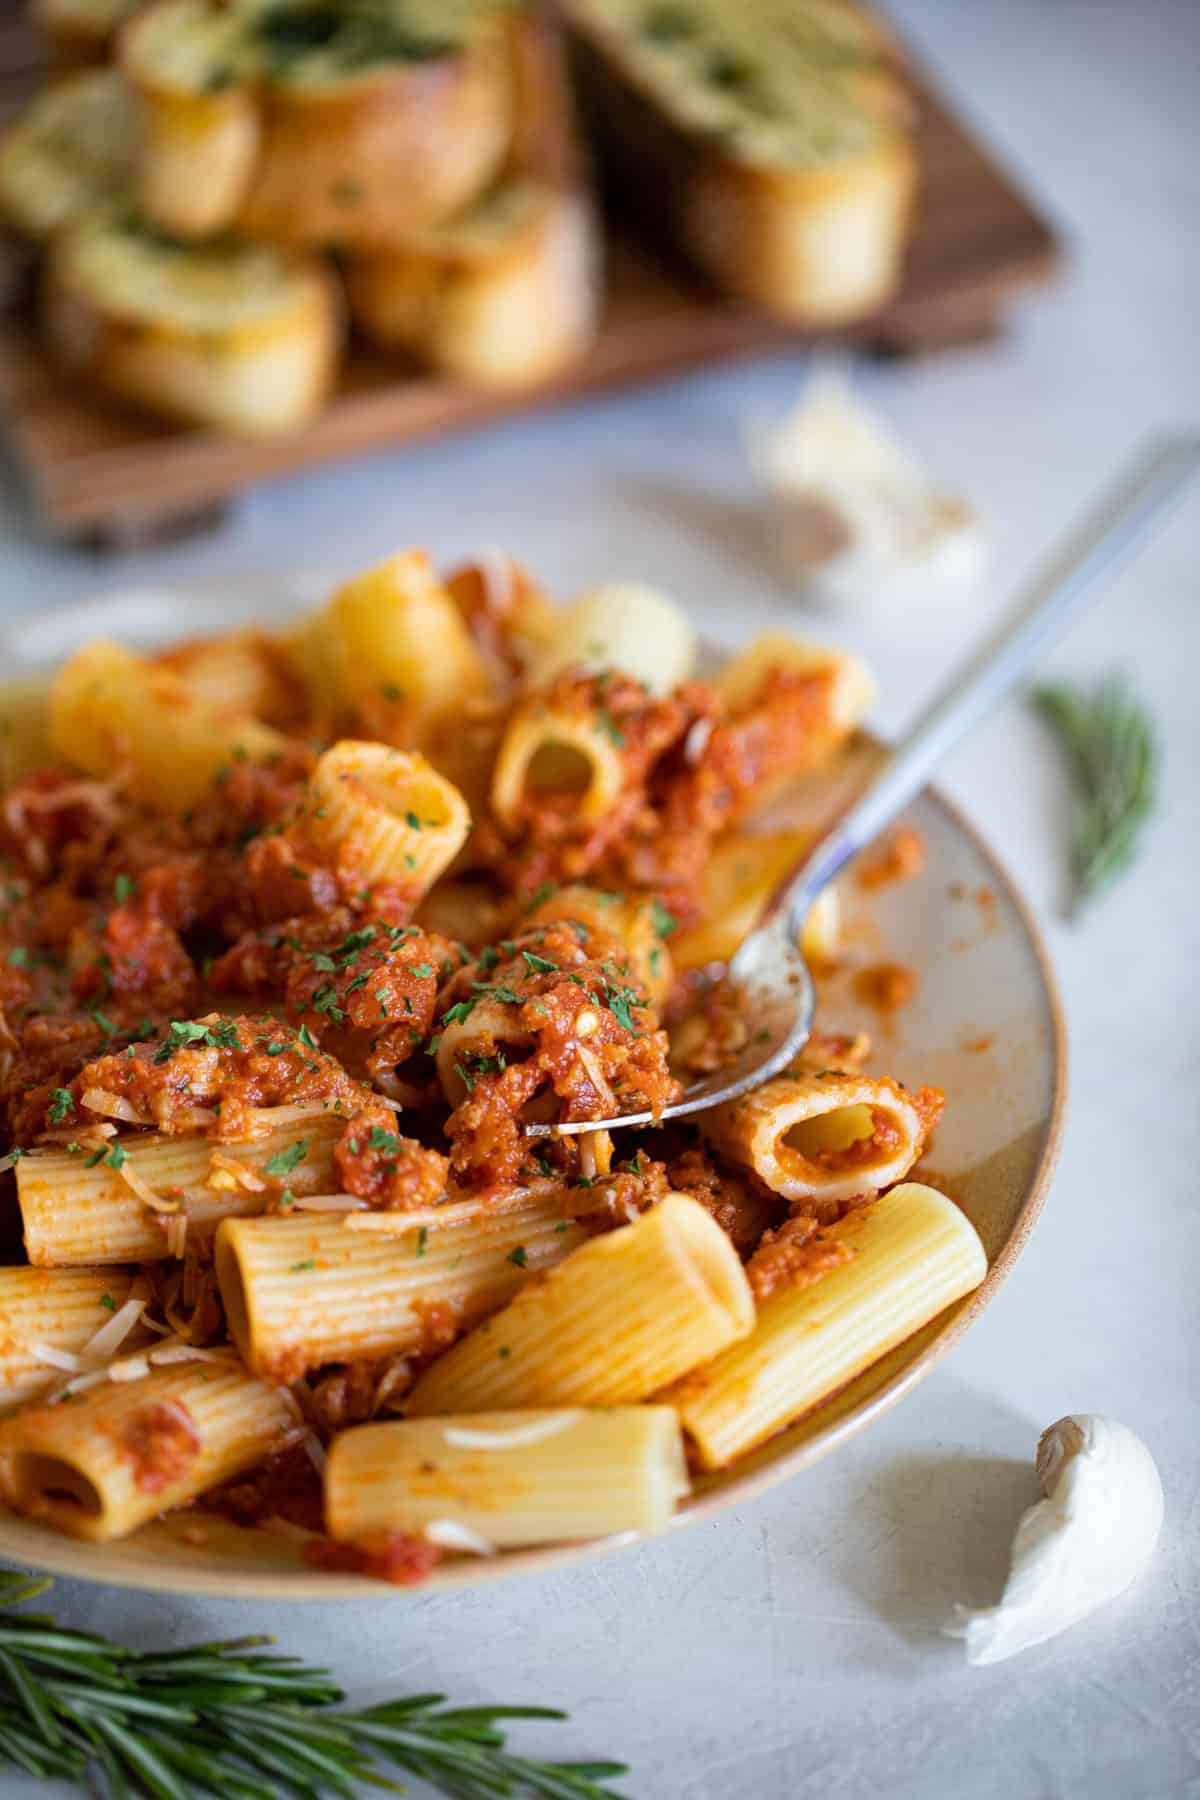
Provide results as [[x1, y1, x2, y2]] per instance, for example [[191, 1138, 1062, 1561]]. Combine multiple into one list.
[[531, 581, 696, 695]]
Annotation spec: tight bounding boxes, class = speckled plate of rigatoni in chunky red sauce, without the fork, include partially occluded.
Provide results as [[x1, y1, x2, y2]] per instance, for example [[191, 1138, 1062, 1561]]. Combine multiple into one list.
[[0, 551, 1065, 1598]]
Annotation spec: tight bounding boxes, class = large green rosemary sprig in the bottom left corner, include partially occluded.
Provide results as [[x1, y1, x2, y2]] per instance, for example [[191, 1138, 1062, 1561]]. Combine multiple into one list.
[[0, 1570, 624, 1800]]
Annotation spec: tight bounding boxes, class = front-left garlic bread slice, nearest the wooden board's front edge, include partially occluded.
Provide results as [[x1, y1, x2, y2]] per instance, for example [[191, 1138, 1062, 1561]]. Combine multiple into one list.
[[43, 212, 340, 437]]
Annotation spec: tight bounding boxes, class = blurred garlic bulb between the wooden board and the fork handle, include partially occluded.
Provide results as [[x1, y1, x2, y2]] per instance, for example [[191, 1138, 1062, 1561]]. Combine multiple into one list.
[[748, 364, 986, 601]]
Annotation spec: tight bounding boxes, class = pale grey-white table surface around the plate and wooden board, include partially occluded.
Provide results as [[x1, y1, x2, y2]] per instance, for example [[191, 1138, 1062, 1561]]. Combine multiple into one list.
[[0, 0, 1200, 1800]]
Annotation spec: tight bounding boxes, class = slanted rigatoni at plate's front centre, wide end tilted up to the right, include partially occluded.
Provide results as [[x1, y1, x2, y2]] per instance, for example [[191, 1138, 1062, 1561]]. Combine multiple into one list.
[[410, 1193, 754, 1418]]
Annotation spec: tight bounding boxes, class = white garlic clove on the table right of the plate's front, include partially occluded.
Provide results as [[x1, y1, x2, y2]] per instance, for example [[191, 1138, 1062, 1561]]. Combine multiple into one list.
[[945, 1413, 1162, 1663]]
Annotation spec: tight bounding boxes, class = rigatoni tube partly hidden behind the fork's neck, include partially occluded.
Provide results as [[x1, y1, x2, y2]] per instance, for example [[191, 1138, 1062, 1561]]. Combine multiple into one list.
[[671, 830, 840, 970]]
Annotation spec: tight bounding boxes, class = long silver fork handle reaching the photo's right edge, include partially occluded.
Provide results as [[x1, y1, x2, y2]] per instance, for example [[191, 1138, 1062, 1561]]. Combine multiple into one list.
[[775, 434, 1200, 941]]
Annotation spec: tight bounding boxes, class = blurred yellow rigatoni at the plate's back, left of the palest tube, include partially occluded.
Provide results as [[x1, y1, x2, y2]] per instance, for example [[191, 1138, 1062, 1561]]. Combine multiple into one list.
[[326, 551, 489, 745]]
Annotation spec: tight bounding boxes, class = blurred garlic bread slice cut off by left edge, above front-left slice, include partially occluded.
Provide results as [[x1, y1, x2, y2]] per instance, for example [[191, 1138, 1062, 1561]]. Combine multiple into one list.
[[0, 68, 137, 243]]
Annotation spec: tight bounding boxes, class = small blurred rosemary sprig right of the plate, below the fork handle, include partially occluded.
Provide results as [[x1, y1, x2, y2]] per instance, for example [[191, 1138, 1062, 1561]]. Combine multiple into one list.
[[1033, 677, 1159, 913]]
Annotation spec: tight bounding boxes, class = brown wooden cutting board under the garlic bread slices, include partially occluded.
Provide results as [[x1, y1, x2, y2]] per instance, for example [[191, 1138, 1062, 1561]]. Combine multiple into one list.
[[0, 5, 1060, 545]]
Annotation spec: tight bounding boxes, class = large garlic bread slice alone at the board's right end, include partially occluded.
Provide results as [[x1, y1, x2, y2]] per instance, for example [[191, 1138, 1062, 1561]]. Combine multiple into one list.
[[565, 0, 916, 326]]
